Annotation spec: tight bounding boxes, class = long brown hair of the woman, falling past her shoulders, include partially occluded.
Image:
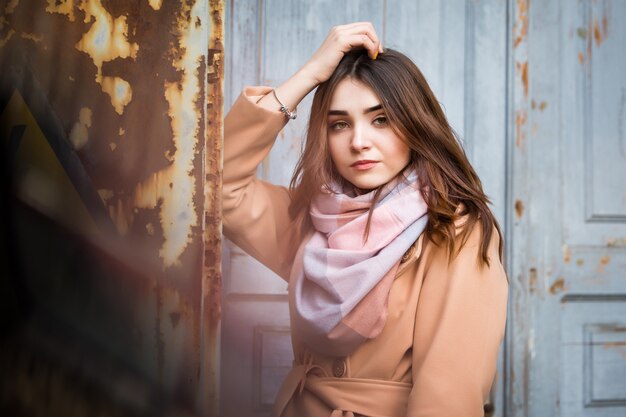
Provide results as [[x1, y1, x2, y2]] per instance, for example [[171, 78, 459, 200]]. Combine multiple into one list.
[[289, 49, 503, 265]]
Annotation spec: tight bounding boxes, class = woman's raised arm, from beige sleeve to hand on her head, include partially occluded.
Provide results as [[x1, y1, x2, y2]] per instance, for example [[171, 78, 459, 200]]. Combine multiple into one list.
[[223, 22, 382, 279]]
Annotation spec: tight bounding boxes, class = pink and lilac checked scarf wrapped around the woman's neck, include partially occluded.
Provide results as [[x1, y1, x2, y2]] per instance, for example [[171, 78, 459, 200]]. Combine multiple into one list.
[[290, 172, 428, 356]]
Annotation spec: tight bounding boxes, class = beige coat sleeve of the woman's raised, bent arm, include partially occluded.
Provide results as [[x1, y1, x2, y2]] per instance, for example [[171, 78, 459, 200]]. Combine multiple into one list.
[[222, 87, 299, 280]]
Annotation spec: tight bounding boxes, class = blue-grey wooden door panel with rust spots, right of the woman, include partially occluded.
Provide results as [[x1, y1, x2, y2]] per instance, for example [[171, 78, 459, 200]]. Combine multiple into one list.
[[507, 0, 626, 417]]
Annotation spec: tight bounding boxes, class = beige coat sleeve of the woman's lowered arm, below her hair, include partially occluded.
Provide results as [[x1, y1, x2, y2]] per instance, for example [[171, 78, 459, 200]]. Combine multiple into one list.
[[408, 224, 508, 417]]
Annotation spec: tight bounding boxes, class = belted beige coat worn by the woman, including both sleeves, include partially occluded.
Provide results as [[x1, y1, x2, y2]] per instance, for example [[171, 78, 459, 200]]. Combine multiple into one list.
[[223, 87, 508, 417]]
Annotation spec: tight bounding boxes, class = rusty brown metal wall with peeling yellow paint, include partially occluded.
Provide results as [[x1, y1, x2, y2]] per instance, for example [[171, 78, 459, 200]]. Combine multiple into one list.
[[0, 0, 224, 415]]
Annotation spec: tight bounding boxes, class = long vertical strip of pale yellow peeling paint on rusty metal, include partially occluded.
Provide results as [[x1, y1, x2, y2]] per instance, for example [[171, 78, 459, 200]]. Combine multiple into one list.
[[134, 2, 206, 267]]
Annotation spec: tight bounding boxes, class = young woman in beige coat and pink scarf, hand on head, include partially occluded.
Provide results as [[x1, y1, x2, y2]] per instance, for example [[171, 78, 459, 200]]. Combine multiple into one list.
[[223, 23, 507, 416]]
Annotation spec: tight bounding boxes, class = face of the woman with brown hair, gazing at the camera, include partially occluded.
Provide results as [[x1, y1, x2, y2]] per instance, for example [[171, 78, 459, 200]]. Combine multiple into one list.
[[327, 78, 410, 190]]
